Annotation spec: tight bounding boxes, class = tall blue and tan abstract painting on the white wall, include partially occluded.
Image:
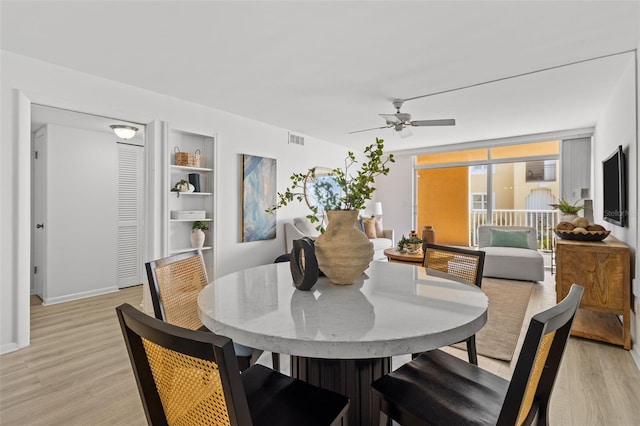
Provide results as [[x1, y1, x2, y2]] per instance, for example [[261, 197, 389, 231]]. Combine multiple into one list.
[[242, 154, 277, 242]]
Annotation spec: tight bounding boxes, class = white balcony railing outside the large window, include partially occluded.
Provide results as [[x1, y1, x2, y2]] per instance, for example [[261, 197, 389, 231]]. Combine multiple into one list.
[[469, 210, 559, 251]]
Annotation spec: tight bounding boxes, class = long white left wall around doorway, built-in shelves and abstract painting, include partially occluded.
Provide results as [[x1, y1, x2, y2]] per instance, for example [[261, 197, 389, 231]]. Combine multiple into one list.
[[0, 51, 346, 353]]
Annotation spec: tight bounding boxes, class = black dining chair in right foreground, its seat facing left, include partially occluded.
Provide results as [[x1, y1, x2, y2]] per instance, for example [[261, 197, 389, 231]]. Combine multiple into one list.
[[372, 284, 584, 426]]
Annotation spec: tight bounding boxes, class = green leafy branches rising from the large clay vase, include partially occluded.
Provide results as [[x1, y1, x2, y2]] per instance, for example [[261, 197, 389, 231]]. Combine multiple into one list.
[[267, 138, 395, 232]]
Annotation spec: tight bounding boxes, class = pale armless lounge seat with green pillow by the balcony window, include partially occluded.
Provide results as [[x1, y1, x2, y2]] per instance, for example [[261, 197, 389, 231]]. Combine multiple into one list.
[[478, 225, 544, 281]]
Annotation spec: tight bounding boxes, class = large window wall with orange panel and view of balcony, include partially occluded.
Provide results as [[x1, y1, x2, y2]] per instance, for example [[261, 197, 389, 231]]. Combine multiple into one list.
[[415, 140, 560, 250]]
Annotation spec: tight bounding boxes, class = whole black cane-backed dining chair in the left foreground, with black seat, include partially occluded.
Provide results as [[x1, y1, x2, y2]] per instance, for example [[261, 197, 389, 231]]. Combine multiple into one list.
[[116, 304, 349, 426]]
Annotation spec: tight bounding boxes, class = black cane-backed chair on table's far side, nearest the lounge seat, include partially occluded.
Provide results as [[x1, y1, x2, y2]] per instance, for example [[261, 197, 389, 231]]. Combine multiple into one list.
[[422, 243, 485, 365]]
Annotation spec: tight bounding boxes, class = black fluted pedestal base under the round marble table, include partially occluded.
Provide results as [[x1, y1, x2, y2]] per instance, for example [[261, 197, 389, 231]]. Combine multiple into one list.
[[291, 356, 391, 426]]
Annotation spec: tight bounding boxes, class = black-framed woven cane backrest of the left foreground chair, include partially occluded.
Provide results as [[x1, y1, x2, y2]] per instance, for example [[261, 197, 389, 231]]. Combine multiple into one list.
[[116, 304, 252, 425]]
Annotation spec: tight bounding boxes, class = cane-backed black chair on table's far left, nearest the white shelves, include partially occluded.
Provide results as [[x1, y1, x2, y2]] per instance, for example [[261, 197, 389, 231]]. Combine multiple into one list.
[[145, 250, 262, 370]]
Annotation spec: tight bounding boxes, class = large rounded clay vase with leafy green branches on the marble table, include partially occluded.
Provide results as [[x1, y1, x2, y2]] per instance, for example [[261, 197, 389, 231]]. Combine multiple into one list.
[[267, 138, 395, 284]]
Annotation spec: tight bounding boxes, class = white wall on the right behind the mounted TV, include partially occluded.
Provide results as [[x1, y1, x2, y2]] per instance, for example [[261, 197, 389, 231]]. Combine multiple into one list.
[[593, 51, 640, 366]]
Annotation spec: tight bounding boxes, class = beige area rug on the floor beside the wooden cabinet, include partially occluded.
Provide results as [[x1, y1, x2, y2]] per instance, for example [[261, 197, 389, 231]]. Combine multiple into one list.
[[453, 277, 534, 361]]
